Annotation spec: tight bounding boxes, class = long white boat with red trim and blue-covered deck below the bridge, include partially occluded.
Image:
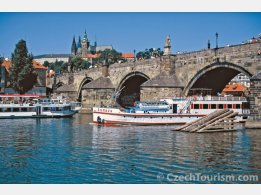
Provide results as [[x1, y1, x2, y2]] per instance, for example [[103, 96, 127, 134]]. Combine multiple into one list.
[[93, 96, 249, 125]]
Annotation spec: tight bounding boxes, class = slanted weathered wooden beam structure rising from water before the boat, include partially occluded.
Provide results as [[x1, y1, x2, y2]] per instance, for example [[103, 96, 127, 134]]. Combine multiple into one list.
[[174, 110, 238, 133]]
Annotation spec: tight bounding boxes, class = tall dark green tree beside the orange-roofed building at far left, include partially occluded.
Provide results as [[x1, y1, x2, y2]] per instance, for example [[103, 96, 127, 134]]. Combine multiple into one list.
[[9, 40, 37, 94]]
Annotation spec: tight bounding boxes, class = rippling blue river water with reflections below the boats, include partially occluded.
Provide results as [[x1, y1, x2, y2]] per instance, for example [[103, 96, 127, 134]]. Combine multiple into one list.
[[0, 114, 261, 184]]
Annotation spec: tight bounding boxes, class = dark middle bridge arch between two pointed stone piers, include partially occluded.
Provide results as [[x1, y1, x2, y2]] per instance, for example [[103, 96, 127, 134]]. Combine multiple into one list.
[[116, 71, 150, 107]]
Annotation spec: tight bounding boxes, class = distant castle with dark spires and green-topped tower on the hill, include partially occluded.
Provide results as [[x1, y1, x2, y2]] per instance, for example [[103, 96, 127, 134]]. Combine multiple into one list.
[[71, 30, 113, 57]]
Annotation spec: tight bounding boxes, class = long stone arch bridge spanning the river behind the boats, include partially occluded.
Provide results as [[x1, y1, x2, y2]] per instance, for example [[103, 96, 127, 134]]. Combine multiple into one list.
[[49, 38, 261, 117]]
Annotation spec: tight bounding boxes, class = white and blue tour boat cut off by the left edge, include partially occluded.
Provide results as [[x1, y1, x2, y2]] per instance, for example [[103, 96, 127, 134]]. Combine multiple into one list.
[[0, 95, 76, 119]]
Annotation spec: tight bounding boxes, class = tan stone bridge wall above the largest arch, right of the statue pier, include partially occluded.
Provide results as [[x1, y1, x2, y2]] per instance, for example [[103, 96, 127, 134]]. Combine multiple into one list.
[[175, 43, 261, 90]]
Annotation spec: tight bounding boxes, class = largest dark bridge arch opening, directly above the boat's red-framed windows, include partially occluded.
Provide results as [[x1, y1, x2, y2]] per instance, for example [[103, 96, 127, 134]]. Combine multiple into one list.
[[183, 62, 252, 96]]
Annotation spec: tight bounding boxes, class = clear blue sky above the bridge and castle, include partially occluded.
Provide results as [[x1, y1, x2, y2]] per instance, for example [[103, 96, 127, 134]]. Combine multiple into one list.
[[0, 13, 261, 57]]
